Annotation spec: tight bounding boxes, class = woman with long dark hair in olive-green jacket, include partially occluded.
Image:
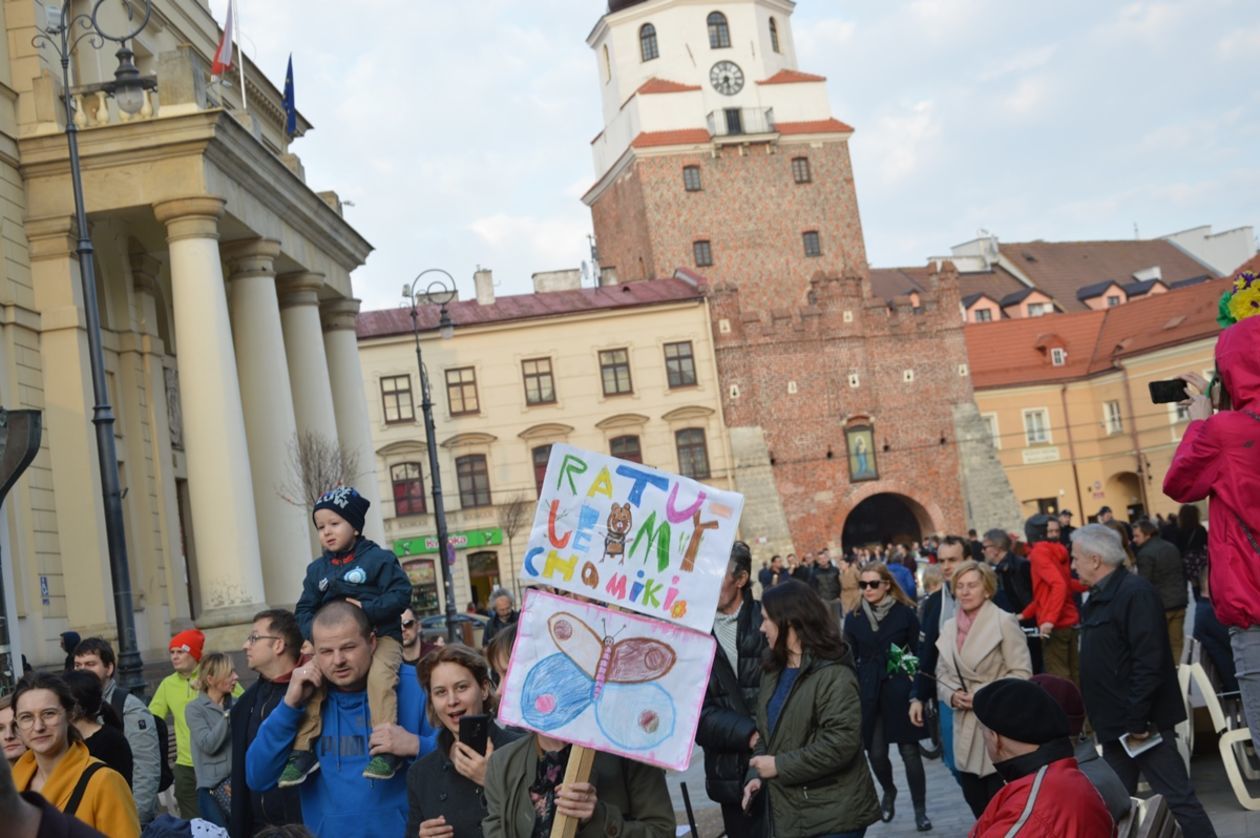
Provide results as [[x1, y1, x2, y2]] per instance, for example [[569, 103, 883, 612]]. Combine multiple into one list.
[[743, 581, 879, 838]]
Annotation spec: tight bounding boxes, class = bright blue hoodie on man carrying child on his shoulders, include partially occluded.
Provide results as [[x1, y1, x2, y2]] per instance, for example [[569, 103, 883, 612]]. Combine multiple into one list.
[[244, 667, 437, 838]]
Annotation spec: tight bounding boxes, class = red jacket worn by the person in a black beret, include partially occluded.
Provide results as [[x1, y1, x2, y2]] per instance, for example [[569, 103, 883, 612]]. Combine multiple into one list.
[[971, 756, 1115, 838]]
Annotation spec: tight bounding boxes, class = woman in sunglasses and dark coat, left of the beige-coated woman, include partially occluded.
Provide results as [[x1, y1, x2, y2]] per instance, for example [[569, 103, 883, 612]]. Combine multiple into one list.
[[844, 562, 932, 832]]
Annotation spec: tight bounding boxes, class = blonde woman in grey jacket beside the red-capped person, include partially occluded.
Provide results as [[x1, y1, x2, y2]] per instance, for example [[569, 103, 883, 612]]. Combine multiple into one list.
[[184, 651, 238, 828]]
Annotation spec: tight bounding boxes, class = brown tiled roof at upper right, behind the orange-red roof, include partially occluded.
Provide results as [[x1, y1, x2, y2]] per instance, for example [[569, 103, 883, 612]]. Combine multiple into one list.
[[999, 238, 1210, 311]]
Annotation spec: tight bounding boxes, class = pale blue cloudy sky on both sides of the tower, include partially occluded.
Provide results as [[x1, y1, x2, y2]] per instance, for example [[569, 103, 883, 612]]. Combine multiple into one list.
[[210, 0, 1260, 310]]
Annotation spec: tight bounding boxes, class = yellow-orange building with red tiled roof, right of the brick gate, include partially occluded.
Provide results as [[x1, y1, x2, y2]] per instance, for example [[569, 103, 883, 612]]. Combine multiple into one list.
[[966, 281, 1227, 524]]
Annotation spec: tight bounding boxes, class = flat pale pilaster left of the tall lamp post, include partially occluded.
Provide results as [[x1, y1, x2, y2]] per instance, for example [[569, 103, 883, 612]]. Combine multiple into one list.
[[21, 215, 117, 635]]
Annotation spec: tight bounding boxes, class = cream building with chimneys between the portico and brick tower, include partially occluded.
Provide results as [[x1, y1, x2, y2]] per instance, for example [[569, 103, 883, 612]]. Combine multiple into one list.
[[358, 272, 733, 614]]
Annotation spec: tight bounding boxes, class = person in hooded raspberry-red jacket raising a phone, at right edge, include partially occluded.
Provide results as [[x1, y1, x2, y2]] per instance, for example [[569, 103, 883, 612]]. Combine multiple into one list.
[[1164, 284, 1260, 747]]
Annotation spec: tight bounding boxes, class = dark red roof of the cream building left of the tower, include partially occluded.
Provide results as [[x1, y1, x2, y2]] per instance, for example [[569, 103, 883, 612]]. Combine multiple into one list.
[[355, 277, 703, 340]]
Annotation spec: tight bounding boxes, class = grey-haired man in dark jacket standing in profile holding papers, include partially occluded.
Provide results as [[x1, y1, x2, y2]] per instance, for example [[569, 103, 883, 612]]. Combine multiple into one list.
[[1072, 524, 1216, 835]]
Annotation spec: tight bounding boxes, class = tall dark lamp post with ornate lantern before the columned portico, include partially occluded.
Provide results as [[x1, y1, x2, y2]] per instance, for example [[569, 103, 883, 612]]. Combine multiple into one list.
[[32, 0, 156, 694]]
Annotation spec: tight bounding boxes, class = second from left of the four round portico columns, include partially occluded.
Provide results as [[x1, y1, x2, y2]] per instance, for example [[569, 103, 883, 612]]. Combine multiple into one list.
[[223, 238, 311, 605]]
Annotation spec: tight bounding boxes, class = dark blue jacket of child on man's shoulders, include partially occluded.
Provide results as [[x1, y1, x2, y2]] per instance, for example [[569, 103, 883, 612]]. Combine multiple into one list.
[[294, 537, 411, 643]]
